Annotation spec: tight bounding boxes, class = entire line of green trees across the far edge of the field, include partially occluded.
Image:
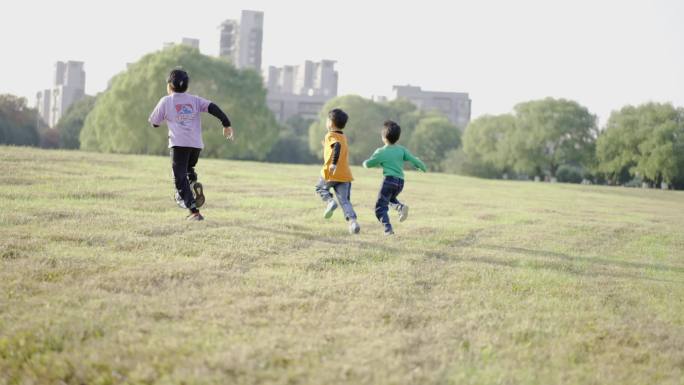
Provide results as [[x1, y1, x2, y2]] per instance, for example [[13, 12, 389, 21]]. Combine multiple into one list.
[[0, 45, 684, 188]]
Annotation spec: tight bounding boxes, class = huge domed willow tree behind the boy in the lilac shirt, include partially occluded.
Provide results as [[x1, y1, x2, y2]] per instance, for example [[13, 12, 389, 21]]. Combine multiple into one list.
[[80, 45, 279, 160]]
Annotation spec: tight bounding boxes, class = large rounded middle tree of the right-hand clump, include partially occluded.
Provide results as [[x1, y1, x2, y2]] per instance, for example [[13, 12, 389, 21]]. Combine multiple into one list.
[[511, 98, 598, 177]]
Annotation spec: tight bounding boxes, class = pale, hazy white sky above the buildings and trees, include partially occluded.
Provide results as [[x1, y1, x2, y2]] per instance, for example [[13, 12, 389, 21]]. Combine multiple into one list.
[[0, 0, 684, 124]]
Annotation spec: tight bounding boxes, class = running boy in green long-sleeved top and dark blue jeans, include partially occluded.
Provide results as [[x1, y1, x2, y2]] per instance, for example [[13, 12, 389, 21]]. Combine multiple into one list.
[[363, 120, 426, 235]]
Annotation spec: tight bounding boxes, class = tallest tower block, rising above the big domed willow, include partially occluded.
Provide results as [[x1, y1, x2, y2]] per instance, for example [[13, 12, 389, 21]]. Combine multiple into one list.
[[219, 11, 264, 71]]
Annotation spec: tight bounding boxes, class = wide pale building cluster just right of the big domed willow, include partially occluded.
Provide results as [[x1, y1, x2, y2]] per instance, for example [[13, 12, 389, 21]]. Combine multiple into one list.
[[264, 60, 338, 122]]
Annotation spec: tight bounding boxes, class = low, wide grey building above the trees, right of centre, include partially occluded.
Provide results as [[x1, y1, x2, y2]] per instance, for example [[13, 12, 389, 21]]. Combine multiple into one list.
[[392, 86, 472, 129]]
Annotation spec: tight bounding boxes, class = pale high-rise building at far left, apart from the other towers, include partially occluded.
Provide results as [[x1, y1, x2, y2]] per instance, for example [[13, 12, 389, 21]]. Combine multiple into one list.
[[36, 61, 85, 128]]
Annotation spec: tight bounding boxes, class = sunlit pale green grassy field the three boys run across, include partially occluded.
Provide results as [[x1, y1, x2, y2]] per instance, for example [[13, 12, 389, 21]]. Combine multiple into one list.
[[0, 147, 684, 385]]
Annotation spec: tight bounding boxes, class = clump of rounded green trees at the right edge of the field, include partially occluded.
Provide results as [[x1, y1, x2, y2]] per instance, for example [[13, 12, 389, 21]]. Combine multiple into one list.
[[452, 98, 684, 188]]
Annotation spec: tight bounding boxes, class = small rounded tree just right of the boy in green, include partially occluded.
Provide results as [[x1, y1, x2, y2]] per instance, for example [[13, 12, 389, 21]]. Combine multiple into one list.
[[409, 116, 461, 171]]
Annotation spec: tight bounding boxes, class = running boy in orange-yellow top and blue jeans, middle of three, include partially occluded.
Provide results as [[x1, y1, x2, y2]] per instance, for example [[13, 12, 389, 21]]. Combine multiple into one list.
[[316, 108, 361, 234]]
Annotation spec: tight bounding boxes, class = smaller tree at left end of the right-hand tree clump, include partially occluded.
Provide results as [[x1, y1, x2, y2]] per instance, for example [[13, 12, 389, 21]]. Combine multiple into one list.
[[463, 114, 516, 177]]
